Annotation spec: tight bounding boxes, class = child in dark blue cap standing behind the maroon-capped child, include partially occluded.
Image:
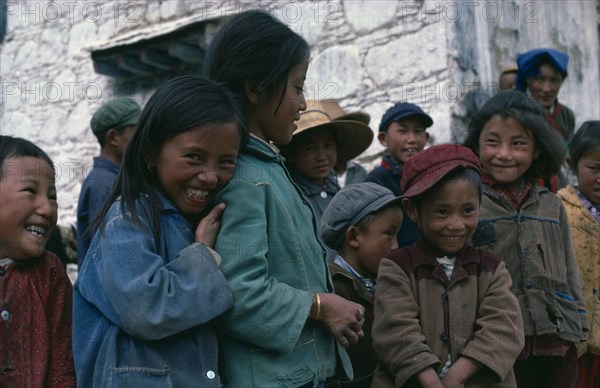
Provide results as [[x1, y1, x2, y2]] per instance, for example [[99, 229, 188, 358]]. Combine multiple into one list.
[[365, 102, 433, 247]]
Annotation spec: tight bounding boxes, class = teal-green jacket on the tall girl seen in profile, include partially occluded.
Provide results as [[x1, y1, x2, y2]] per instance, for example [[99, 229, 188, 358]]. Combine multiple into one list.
[[215, 136, 352, 387]]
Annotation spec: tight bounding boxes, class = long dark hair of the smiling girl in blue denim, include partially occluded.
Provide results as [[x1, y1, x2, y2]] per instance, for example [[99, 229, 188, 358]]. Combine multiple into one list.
[[93, 75, 249, 246]]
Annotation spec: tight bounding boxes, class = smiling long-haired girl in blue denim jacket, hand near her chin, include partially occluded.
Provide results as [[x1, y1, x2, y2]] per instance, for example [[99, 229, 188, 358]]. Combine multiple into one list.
[[73, 76, 247, 387]]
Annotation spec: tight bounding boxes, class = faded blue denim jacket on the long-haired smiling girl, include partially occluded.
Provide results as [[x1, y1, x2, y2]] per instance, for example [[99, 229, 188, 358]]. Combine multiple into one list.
[[73, 192, 233, 388]]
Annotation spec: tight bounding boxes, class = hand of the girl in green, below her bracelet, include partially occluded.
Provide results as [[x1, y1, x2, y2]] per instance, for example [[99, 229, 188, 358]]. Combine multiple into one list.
[[319, 294, 365, 348]]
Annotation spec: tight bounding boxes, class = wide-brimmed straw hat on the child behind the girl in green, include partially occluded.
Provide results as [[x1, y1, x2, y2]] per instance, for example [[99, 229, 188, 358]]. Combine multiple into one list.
[[282, 100, 374, 160]]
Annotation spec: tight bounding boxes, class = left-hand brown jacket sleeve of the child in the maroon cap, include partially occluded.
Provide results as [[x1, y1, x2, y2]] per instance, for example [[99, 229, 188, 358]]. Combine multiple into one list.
[[372, 259, 440, 387]]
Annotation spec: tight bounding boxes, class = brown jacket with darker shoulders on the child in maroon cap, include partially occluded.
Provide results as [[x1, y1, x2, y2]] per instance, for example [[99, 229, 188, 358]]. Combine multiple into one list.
[[372, 239, 524, 388]]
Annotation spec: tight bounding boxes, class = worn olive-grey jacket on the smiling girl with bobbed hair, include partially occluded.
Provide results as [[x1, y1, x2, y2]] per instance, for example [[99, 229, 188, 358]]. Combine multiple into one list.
[[472, 185, 588, 344]]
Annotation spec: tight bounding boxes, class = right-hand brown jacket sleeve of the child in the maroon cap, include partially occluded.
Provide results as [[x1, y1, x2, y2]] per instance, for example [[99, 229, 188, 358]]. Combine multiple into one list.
[[461, 261, 525, 381]]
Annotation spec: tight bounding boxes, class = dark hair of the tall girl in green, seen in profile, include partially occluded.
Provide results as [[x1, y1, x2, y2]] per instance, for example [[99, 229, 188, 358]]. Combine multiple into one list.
[[203, 10, 310, 111]]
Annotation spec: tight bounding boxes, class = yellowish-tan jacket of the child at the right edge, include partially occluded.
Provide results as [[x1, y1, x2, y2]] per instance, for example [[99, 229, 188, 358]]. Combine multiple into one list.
[[558, 186, 600, 354]]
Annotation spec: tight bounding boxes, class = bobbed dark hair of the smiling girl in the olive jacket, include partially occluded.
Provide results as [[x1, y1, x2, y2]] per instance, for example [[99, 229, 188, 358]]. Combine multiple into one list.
[[463, 90, 566, 178]]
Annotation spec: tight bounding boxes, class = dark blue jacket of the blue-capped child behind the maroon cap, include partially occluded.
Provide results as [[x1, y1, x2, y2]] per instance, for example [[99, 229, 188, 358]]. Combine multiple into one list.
[[365, 155, 421, 248]]
